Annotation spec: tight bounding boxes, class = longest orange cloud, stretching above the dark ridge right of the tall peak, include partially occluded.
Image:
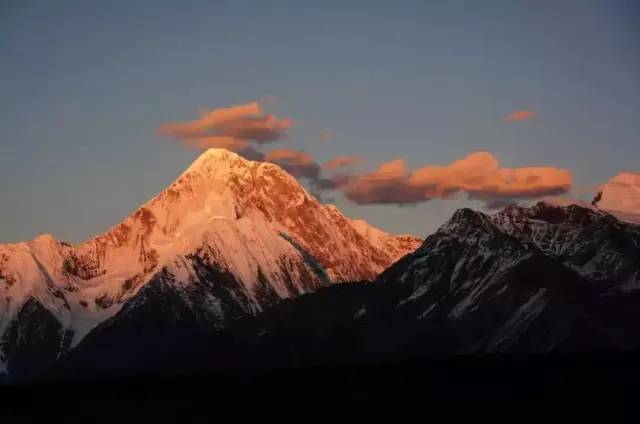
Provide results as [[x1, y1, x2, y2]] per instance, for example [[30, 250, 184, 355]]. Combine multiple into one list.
[[345, 152, 572, 204]]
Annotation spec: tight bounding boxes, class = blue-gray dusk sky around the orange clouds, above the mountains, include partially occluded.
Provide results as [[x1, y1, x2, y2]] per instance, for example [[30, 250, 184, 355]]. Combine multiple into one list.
[[0, 0, 640, 242]]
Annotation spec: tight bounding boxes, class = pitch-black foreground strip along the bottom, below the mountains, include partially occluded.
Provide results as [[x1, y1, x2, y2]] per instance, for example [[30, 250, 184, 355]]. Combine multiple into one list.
[[0, 352, 640, 422]]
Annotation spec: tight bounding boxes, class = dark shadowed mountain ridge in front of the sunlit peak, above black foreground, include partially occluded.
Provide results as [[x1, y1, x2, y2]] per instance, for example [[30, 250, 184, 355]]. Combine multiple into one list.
[[51, 203, 640, 376]]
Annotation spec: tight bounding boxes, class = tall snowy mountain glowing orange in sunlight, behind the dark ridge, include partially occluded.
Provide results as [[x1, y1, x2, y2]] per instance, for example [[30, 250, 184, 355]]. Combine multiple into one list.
[[0, 149, 420, 373]]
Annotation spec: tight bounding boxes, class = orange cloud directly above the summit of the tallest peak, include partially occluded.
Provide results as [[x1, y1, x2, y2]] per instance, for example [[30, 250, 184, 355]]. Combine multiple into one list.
[[158, 102, 293, 142]]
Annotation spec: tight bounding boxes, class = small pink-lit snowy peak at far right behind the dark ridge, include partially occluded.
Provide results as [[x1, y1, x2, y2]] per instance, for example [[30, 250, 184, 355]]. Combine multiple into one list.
[[593, 172, 640, 223]]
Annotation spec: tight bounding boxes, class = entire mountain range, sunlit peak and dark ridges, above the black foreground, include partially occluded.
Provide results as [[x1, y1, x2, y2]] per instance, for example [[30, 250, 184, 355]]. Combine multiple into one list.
[[0, 149, 640, 379]]
